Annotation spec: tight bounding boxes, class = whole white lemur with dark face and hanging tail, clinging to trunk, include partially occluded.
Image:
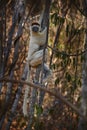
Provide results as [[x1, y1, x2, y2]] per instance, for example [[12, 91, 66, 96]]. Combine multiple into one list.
[[23, 9, 52, 115]]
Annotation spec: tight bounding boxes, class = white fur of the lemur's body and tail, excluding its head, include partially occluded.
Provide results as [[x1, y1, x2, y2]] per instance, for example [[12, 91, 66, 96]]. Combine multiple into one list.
[[23, 23, 47, 116]]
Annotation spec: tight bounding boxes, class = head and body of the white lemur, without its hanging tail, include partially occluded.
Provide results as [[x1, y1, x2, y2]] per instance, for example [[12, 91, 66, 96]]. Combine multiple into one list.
[[28, 22, 47, 67]]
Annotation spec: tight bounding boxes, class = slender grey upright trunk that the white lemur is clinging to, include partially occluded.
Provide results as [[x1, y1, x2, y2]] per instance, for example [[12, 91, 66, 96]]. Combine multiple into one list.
[[26, 0, 51, 130]]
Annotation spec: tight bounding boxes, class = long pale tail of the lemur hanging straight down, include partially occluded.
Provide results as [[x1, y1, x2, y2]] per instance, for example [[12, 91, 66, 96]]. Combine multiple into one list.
[[23, 65, 30, 116]]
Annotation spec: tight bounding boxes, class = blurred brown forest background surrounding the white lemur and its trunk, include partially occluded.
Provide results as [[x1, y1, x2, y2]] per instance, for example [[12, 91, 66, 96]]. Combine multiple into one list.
[[0, 0, 87, 130]]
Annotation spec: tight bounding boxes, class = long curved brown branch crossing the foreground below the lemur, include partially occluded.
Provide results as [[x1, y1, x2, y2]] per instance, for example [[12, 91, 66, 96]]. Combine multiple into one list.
[[0, 79, 87, 121]]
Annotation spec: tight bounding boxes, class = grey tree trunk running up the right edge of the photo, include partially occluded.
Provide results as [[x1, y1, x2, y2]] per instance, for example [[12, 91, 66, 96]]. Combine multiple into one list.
[[78, 0, 87, 130]]
